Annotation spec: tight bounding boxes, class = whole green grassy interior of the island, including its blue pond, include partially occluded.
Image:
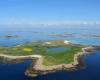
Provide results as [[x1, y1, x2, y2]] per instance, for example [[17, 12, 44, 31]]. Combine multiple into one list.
[[0, 41, 84, 65]]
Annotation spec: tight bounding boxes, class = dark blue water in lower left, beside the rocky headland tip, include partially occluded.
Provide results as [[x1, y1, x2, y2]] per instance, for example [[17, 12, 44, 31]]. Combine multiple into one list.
[[0, 60, 31, 80]]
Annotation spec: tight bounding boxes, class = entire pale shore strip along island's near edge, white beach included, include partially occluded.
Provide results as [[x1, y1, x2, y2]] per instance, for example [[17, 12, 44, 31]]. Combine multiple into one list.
[[0, 46, 94, 77]]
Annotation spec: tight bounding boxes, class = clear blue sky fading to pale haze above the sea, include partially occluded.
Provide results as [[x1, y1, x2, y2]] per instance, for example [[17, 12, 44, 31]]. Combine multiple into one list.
[[0, 0, 100, 24]]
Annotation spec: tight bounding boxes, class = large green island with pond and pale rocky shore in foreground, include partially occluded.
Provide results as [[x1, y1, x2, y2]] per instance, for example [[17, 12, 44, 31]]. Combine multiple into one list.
[[0, 40, 97, 77]]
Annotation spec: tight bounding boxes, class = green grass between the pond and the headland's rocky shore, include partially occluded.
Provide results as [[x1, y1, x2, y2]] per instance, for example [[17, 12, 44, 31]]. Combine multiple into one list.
[[43, 45, 82, 65]]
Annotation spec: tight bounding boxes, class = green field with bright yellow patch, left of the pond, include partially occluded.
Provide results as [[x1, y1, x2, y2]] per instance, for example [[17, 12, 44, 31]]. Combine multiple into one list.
[[0, 44, 46, 56]]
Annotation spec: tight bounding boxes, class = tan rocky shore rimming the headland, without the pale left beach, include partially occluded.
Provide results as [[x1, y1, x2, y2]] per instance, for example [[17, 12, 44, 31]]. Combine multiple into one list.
[[25, 47, 93, 77]]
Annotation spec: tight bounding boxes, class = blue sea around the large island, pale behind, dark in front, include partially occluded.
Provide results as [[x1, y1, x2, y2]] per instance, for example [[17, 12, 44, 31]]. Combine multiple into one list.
[[0, 26, 100, 80]]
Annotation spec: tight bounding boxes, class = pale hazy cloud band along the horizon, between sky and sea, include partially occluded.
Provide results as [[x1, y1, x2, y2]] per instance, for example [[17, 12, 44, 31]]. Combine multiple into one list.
[[0, 21, 100, 26]]
